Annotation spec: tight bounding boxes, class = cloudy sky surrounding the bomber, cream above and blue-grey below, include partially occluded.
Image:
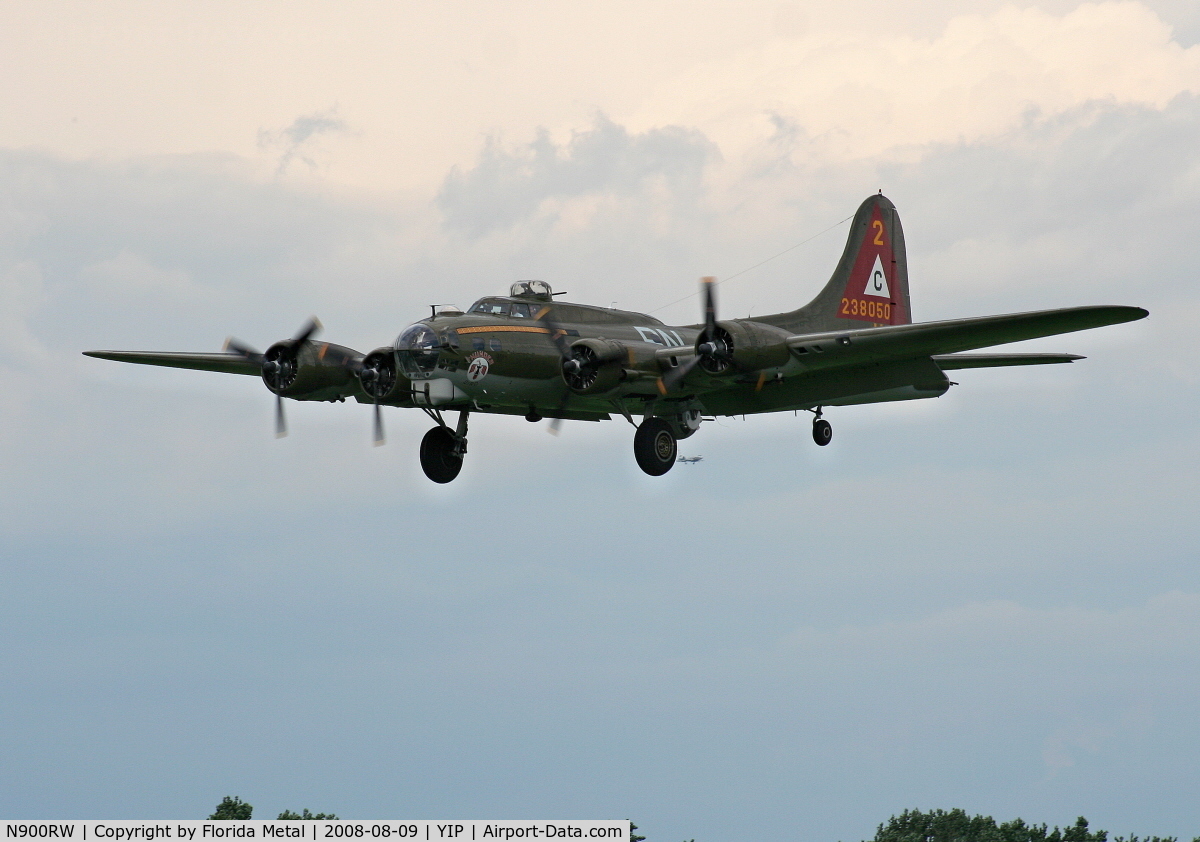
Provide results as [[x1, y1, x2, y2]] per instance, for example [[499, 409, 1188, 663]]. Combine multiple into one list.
[[0, 0, 1200, 842]]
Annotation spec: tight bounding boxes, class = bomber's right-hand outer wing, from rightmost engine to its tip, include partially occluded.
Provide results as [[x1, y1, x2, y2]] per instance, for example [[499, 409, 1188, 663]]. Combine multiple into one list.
[[787, 306, 1150, 368]]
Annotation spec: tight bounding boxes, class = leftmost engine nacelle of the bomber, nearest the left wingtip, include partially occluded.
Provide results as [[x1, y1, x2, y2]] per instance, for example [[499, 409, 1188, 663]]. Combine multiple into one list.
[[262, 339, 362, 401]]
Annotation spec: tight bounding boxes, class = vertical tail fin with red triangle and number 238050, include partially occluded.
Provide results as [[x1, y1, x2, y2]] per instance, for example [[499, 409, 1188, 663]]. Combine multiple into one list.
[[761, 193, 912, 333]]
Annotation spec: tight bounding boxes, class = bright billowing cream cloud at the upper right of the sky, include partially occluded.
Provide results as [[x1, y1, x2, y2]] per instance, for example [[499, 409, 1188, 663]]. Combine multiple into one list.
[[629, 1, 1200, 160]]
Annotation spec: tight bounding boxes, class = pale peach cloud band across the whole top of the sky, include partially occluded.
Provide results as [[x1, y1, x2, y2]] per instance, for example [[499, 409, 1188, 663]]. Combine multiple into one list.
[[0, 0, 1198, 190]]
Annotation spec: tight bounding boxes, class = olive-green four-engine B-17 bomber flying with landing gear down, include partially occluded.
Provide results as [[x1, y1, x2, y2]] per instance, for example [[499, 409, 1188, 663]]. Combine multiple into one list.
[[84, 193, 1148, 482]]
